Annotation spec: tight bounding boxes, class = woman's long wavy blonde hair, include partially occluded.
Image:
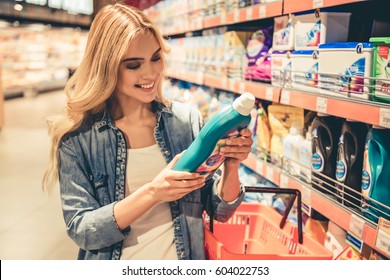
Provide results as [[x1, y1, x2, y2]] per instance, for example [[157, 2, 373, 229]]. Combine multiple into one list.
[[42, 4, 169, 192]]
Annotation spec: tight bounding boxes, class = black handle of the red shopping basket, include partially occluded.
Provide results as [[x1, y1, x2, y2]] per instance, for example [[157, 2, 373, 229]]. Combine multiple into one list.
[[210, 186, 303, 244]]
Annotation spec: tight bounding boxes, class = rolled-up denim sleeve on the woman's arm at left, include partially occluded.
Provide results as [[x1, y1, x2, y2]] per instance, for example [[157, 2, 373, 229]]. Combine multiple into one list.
[[58, 138, 130, 250]]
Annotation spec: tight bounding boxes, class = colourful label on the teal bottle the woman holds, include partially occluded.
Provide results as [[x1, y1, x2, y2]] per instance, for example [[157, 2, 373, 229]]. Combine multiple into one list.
[[195, 131, 239, 174]]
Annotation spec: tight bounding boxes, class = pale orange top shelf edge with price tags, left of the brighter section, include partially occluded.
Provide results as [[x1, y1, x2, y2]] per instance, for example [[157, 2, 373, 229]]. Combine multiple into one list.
[[203, 1, 283, 28]]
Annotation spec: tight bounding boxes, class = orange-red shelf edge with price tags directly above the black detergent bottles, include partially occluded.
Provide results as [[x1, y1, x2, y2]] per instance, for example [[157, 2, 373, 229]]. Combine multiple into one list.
[[280, 88, 390, 128]]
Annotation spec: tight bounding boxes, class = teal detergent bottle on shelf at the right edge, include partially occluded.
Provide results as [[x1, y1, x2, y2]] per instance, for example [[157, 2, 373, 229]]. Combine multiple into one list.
[[362, 126, 390, 222]]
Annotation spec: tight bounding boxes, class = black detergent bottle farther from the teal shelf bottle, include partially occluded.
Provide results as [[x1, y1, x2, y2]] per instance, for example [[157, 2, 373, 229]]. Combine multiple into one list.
[[311, 113, 341, 194]]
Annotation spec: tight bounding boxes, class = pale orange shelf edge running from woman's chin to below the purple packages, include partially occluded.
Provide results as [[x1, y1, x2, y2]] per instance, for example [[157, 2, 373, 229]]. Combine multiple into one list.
[[168, 71, 281, 102]]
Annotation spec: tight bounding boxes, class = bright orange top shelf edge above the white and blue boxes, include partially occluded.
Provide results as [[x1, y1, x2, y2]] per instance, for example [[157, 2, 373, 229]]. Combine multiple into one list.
[[284, 0, 369, 14]]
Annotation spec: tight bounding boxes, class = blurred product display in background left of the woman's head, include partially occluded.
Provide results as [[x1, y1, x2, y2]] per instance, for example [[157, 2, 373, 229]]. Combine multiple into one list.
[[0, 21, 87, 98]]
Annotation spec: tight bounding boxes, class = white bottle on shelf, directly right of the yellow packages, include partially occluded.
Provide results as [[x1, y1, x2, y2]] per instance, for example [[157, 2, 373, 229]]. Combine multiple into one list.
[[283, 125, 304, 177]]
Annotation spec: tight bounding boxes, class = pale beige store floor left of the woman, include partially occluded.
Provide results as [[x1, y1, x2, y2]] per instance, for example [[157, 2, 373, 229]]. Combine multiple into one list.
[[0, 90, 77, 260]]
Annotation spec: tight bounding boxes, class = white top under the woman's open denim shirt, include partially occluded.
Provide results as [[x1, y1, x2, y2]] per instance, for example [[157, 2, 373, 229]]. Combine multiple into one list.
[[121, 144, 177, 260]]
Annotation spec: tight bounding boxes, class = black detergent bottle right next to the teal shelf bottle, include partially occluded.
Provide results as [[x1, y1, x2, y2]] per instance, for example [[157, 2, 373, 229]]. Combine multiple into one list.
[[336, 119, 368, 208]]
